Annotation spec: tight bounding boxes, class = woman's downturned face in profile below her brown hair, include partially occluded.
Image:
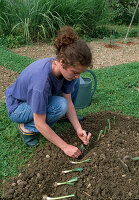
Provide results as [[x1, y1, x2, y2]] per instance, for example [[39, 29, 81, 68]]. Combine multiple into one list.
[[60, 65, 87, 81]]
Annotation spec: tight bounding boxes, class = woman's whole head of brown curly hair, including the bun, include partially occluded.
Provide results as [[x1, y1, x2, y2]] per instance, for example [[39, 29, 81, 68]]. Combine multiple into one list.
[[54, 26, 92, 68]]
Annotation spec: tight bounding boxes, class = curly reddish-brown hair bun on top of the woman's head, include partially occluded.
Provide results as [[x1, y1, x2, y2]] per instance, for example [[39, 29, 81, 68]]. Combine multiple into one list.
[[54, 26, 79, 51]]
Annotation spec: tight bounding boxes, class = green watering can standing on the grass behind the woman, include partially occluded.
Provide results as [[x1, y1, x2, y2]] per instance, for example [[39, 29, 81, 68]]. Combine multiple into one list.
[[75, 69, 97, 108]]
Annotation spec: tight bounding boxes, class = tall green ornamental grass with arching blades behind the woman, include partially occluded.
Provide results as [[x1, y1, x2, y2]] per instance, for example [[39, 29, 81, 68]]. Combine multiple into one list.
[[0, 0, 108, 43]]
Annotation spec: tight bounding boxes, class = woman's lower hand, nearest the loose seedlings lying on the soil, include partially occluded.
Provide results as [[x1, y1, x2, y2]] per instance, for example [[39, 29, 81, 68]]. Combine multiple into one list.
[[62, 144, 81, 158]]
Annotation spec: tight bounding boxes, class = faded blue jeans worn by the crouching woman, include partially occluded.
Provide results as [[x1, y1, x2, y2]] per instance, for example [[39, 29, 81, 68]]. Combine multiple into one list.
[[9, 79, 79, 132]]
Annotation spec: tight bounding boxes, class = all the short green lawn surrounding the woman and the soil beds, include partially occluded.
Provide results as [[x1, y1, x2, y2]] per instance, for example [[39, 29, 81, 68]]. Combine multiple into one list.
[[0, 48, 139, 195]]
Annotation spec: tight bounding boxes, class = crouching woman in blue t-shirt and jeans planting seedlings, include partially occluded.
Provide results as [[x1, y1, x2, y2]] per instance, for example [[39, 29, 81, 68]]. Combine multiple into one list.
[[5, 26, 92, 158]]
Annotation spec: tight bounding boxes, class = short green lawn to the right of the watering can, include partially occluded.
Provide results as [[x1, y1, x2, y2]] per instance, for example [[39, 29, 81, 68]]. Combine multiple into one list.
[[78, 63, 139, 118]]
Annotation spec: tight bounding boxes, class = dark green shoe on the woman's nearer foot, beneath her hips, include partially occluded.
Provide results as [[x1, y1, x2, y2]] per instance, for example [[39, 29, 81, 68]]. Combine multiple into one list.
[[18, 124, 39, 147]]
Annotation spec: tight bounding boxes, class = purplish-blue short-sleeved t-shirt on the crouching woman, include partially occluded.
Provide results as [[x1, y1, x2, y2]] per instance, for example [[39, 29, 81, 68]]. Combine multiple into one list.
[[5, 58, 75, 114]]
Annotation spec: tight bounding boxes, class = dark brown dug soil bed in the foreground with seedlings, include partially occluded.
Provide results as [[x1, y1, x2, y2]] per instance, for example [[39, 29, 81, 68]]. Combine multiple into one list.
[[3, 112, 139, 200]]
